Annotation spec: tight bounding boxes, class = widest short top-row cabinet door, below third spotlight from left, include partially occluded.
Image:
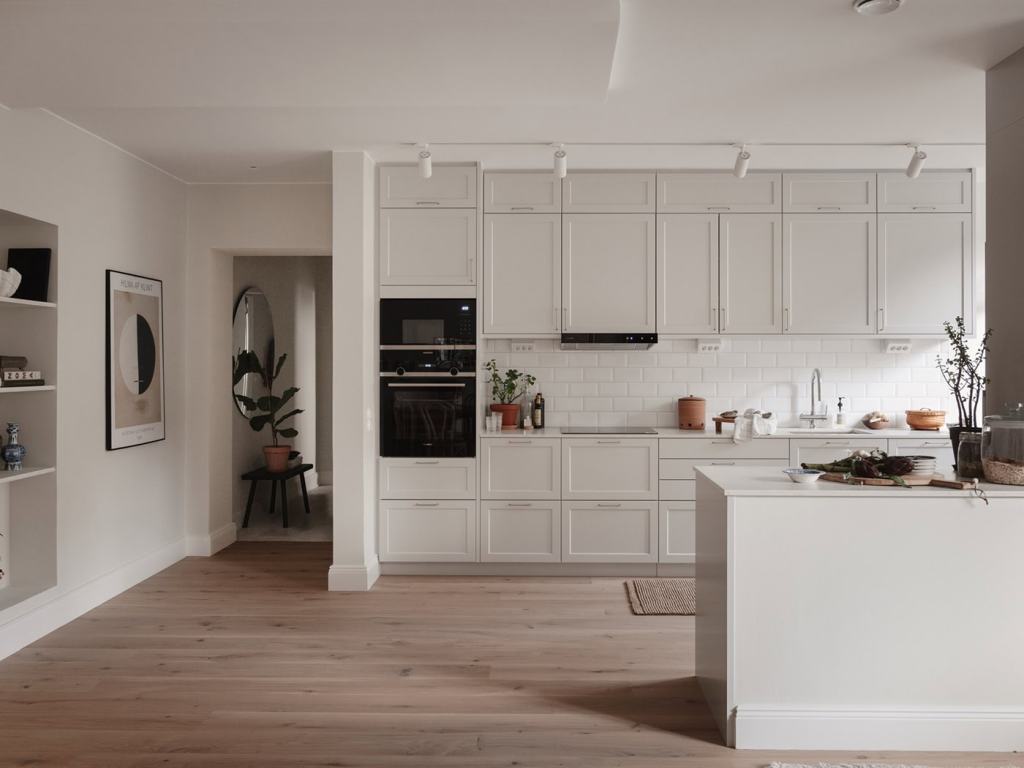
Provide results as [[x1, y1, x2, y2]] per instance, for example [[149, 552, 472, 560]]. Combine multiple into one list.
[[657, 171, 782, 213]]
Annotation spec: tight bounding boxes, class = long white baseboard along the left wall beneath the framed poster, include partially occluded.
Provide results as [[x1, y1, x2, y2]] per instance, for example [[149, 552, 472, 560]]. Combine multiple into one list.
[[0, 539, 185, 658]]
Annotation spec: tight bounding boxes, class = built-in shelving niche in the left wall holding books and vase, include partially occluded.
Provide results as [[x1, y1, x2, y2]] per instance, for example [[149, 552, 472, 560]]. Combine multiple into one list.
[[0, 210, 58, 623]]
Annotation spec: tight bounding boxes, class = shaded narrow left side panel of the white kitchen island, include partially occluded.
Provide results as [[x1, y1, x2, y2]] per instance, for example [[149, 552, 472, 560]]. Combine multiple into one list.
[[695, 470, 732, 746]]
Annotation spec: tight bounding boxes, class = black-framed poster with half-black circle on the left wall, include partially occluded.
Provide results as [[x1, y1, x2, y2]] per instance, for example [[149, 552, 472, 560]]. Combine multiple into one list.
[[106, 269, 166, 451]]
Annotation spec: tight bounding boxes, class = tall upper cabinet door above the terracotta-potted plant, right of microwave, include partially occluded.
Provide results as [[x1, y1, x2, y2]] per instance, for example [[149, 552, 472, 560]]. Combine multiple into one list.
[[483, 213, 562, 336]]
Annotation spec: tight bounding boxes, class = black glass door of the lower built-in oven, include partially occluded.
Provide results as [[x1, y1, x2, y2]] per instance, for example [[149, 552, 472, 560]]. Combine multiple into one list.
[[380, 377, 476, 458]]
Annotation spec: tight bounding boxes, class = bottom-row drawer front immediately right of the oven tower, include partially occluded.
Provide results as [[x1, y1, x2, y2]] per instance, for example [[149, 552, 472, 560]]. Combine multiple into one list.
[[480, 502, 562, 562]]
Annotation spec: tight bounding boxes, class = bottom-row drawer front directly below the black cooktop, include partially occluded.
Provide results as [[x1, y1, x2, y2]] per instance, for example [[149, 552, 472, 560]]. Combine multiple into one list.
[[562, 502, 657, 562]]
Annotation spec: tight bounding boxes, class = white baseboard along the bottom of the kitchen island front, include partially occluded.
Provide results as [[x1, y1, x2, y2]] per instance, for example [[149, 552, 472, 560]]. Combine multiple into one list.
[[735, 707, 1024, 752]]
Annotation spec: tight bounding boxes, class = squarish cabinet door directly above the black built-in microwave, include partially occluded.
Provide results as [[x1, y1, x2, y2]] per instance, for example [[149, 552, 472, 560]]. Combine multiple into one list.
[[379, 208, 476, 286]]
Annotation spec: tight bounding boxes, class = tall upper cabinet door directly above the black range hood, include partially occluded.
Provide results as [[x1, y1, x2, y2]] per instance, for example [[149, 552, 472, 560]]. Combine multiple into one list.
[[562, 213, 655, 333]]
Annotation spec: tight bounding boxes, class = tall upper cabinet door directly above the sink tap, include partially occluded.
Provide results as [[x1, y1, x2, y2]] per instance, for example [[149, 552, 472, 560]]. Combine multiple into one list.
[[782, 213, 879, 334]]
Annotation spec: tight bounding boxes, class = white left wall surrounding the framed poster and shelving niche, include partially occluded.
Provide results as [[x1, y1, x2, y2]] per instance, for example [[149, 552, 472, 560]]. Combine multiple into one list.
[[0, 110, 189, 656]]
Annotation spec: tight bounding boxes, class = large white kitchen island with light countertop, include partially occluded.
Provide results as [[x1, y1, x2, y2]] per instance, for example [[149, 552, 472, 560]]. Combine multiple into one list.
[[696, 466, 1024, 751]]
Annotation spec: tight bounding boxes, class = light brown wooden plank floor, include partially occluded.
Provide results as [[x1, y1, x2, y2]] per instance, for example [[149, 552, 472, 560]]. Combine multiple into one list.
[[0, 543, 1015, 768]]
